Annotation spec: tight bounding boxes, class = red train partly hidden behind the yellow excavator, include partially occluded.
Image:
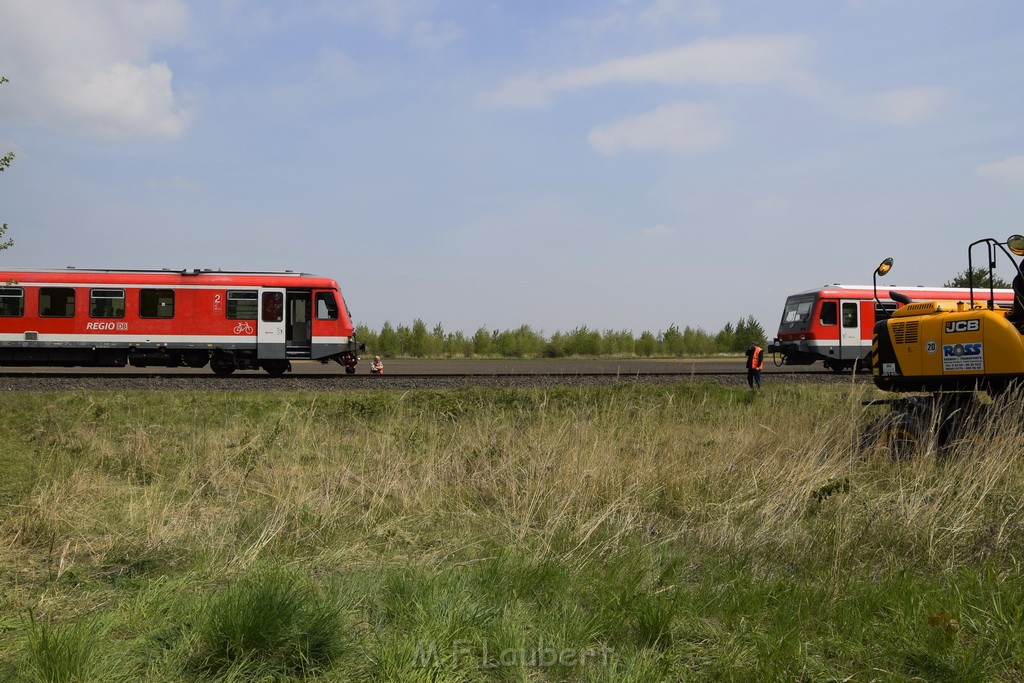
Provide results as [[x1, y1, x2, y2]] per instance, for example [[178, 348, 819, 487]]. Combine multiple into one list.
[[767, 285, 1014, 373]]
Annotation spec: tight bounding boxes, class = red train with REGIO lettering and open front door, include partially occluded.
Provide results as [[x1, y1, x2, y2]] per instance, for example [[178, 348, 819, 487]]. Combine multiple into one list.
[[0, 268, 361, 376]]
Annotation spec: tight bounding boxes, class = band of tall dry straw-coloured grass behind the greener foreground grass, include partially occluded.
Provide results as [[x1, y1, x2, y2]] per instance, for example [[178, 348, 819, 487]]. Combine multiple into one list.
[[6, 389, 1022, 570]]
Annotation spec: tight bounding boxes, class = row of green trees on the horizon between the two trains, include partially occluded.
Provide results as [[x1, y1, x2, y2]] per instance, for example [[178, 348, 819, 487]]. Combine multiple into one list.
[[355, 315, 765, 358]]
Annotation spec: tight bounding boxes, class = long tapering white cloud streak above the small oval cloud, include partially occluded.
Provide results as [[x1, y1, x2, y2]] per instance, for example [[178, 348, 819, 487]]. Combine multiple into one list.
[[480, 36, 810, 106]]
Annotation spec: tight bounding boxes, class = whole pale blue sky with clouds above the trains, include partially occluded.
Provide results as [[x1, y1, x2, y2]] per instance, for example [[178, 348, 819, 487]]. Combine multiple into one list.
[[0, 0, 1024, 337]]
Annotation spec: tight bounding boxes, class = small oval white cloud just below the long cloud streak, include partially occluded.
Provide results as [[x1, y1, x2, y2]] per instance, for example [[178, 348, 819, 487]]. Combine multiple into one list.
[[589, 102, 728, 155]]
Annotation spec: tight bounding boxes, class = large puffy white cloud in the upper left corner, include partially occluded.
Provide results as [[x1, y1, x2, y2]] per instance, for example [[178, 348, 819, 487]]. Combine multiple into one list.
[[0, 0, 190, 137]]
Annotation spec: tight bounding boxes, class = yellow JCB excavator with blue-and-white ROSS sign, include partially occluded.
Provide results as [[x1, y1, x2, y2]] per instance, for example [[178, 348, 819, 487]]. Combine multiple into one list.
[[862, 234, 1024, 456]]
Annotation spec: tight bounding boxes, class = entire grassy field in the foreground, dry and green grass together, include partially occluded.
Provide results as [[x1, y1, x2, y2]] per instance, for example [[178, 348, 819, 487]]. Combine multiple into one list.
[[0, 385, 1024, 683]]
